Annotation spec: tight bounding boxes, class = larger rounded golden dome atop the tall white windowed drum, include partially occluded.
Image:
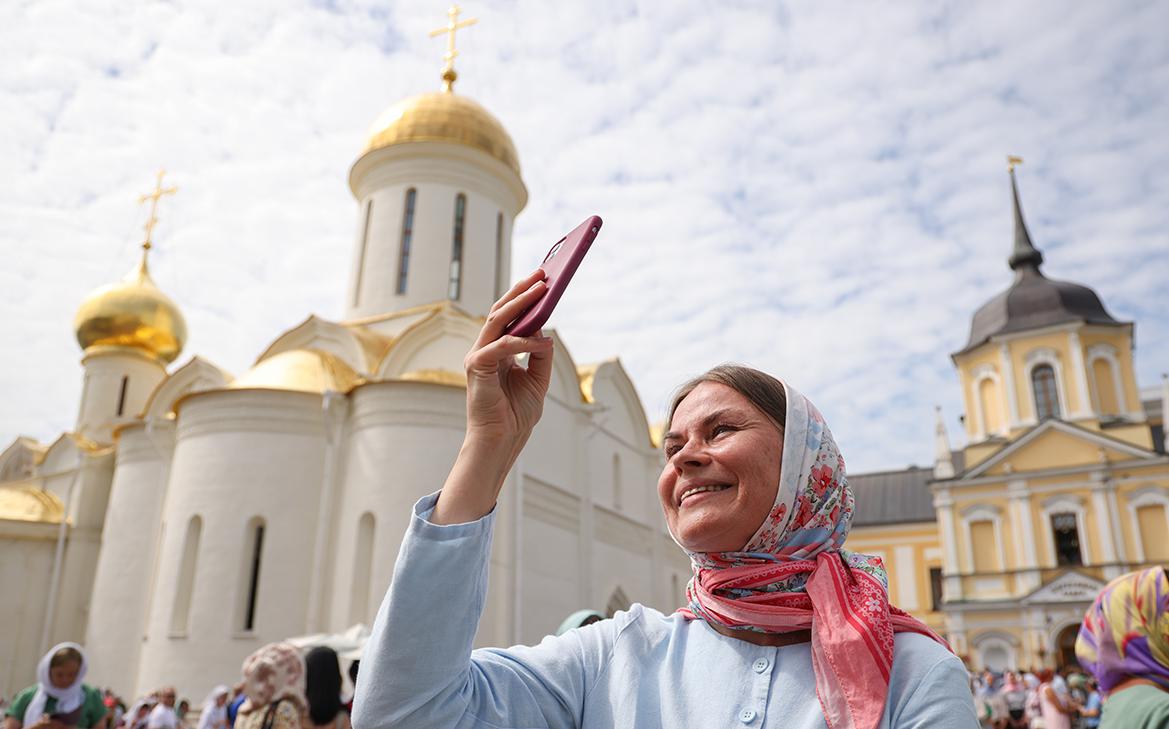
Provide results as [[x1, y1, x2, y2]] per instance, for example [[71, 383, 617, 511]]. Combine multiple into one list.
[[362, 91, 519, 175]]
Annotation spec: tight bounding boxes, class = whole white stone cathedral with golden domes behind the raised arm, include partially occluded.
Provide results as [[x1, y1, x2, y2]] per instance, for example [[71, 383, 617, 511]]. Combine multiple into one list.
[[0, 47, 690, 699]]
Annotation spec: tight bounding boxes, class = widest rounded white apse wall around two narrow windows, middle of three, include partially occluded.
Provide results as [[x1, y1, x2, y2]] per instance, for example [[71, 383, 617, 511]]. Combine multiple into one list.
[[138, 390, 324, 695]]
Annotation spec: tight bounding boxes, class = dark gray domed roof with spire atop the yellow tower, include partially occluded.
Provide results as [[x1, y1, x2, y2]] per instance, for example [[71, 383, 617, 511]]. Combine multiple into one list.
[[959, 171, 1123, 354]]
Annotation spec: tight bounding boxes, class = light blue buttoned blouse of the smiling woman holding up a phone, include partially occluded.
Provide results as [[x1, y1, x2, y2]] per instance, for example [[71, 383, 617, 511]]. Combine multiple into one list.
[[353, 494, 978, 729]]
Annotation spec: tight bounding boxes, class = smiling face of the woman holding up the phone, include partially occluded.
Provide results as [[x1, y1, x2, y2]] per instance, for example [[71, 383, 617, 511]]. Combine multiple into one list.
[[658, 382, 783, 551]]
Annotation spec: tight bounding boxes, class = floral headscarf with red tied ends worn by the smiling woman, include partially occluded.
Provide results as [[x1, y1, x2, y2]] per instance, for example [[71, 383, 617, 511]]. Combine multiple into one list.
[[679, 383, 948, 729]]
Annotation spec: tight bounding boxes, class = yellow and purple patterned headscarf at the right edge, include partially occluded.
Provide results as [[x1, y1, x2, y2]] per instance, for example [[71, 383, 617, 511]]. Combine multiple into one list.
[[1075, 567, 1169, 692]]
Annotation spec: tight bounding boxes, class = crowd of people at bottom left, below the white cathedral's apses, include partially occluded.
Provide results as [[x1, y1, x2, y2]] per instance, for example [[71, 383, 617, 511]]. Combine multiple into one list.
[[0, 643, 358, 729]]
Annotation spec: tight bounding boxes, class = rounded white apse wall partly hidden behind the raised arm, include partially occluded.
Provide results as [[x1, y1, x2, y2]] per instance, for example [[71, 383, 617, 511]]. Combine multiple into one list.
[[330, 382, 466, 630]]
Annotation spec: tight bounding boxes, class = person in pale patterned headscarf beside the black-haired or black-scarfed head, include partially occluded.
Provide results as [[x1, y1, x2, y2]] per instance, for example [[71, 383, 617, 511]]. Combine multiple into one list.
[[235, 643, 309, 729]]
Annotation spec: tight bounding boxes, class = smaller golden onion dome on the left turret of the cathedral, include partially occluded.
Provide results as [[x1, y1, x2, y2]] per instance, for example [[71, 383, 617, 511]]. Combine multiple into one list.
[[74, 255, 187, 362]]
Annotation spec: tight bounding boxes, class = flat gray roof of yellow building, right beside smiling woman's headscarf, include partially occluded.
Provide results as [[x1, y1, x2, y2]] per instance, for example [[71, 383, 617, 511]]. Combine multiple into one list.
[[849, 461, 960, 527]]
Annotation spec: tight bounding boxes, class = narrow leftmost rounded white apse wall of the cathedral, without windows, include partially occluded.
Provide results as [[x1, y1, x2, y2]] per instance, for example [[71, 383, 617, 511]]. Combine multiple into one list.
[[85, 421, 174, 696]]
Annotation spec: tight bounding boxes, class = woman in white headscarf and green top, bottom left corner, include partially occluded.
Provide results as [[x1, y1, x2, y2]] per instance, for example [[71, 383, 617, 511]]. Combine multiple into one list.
[[4, 643, 109, 729]]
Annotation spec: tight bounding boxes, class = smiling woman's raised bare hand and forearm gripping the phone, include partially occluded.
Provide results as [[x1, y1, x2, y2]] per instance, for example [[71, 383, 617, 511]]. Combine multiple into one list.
[[430, 269, 552, 525]]
